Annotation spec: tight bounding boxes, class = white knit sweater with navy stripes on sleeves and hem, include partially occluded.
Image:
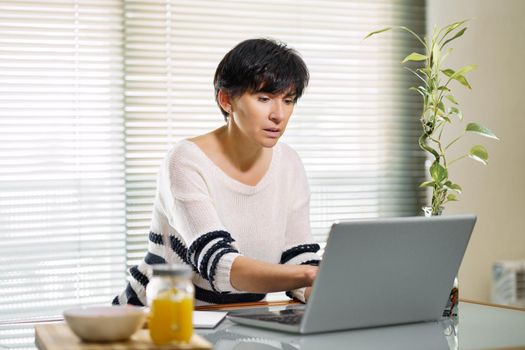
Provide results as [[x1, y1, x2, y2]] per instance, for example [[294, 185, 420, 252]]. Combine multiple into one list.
[[113, 140, 319, 305]]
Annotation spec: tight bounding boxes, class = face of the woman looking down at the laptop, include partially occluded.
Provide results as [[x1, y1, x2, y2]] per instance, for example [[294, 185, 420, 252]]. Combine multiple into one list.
[[230, 92, 295, 147]]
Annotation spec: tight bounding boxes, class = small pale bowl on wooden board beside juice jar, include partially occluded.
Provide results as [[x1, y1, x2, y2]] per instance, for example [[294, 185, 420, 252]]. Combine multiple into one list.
[[64, 305, 146, 342]]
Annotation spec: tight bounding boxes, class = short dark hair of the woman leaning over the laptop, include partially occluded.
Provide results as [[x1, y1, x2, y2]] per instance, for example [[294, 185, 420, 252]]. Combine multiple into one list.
[[213, 39, 310, 118]]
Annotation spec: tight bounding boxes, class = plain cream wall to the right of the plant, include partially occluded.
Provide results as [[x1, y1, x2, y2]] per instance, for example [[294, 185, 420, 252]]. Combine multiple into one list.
[[427, 0, 525, 301]]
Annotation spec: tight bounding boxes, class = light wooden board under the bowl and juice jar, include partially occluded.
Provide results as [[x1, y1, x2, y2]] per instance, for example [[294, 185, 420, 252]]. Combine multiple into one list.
[[35, 323, 212, 350]]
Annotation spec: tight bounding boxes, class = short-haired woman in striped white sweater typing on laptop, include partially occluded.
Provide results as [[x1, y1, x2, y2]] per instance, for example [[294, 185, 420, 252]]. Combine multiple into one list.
[[113, 39, 319, 305]]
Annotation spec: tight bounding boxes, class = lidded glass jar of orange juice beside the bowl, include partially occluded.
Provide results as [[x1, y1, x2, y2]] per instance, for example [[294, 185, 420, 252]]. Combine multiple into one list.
[[146, 264, 195, 345]]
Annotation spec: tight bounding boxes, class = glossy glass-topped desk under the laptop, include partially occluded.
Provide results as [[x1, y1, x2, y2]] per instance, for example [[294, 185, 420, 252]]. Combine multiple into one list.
[[0, 301, 525, 350]]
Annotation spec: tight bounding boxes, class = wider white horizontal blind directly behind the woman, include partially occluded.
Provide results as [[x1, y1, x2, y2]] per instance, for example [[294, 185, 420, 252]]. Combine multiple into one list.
[[124, 0, 425, 265]]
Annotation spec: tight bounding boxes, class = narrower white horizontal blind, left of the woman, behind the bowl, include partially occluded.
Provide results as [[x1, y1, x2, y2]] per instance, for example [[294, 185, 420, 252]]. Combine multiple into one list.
[[0, 0, 125, 338]]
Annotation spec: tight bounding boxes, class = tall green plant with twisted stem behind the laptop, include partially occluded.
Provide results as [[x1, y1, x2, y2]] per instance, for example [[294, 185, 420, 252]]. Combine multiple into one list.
[[365, 21, 499, 213]]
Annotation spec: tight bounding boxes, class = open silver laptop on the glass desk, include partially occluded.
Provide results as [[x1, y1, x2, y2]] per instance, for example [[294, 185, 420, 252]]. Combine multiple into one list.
[[228, 215, 476, 334]]
